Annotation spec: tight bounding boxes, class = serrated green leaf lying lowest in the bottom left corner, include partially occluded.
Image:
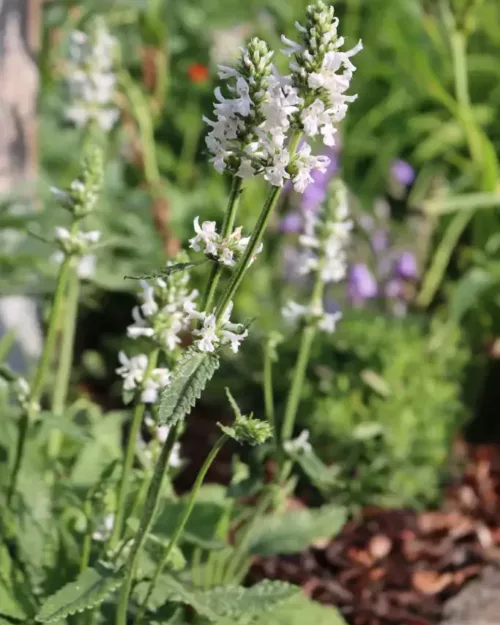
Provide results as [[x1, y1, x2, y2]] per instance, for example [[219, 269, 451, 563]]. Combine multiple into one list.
[[36, 564, 123, 623]]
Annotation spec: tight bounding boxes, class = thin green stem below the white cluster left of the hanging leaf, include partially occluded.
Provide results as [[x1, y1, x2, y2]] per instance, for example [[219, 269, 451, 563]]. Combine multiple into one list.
[[109, 349, 159, 549]]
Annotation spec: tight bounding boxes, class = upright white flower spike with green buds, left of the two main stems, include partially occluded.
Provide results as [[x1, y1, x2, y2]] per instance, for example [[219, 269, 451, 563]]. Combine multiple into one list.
[[127, 270, 198, 352]]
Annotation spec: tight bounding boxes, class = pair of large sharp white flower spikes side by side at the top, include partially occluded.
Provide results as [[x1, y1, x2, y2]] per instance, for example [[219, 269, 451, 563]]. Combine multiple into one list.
[[206, 2, 361, 193]]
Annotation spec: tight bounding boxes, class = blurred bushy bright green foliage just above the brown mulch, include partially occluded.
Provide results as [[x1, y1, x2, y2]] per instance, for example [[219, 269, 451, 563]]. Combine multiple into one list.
[[300, 315, 466, 507]]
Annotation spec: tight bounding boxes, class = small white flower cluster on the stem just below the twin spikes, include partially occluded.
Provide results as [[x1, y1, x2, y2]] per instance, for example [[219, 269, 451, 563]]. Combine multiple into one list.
[[189, 217, 262, 267]]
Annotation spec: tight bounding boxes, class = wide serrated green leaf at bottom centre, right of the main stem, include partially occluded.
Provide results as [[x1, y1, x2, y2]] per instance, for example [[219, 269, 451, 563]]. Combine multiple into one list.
[[154, 575, 300, 622]]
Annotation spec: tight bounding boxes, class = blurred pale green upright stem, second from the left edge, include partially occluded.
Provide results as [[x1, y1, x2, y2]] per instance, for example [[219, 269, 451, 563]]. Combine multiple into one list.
[[48, 269, 80, 460]]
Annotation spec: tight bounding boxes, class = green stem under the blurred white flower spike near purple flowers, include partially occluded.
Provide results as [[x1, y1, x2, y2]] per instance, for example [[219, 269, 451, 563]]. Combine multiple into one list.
[[280, 274, 324, 480]]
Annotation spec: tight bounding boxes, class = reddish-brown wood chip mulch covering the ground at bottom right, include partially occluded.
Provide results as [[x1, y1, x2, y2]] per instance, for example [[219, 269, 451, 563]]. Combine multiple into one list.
[[250, 445, 500, 625]]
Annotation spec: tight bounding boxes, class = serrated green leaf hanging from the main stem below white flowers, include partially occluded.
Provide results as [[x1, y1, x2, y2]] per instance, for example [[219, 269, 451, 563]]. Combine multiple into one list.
[[158, 349, 220, 426]]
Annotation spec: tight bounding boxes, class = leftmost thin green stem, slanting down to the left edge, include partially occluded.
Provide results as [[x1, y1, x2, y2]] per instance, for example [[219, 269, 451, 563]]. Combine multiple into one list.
[[7, 256, 71, 504]]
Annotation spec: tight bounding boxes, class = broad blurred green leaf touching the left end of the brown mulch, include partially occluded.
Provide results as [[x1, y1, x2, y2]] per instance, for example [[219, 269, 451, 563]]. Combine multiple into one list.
[[249, 505, 346, 556]]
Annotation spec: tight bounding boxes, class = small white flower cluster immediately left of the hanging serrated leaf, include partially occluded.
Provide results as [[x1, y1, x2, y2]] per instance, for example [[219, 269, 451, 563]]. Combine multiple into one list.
[[116, 352, 171, 404]]
